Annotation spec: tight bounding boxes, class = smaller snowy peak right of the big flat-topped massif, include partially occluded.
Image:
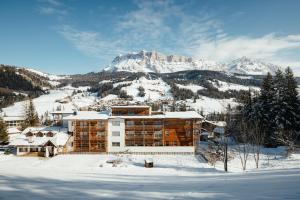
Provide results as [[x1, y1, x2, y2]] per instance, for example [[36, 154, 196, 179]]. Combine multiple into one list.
[[227, 57, 280, 75]]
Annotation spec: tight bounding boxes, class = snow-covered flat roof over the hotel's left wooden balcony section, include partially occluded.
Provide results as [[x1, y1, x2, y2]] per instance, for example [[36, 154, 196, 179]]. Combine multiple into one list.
[[64, 111, 109, 120]]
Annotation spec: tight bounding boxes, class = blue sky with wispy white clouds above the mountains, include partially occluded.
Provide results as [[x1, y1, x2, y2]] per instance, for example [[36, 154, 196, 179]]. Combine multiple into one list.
[[0, 0, 300, 75]]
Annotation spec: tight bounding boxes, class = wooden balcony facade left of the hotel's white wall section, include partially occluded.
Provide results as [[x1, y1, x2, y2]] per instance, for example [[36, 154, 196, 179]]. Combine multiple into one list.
[[73, 120, 107, 152]]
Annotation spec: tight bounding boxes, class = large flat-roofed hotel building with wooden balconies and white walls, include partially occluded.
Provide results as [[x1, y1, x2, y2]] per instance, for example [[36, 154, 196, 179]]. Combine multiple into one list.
[[64, 106, 203, 153]]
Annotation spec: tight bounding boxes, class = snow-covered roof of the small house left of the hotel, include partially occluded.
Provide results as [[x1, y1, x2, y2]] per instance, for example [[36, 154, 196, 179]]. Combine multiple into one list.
[[9, 127, 70, 146]]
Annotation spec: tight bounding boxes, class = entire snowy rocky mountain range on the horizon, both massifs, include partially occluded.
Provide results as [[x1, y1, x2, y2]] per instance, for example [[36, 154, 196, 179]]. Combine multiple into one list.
[[105, 51, 279, 75]]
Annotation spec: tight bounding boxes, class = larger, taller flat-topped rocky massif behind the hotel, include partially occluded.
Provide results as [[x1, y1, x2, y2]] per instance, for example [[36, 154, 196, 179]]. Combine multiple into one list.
[[105, 51, 224, 73]]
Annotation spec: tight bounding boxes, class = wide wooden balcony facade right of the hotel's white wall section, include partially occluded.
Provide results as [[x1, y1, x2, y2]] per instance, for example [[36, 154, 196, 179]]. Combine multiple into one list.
[[125, 118, 200, 146]]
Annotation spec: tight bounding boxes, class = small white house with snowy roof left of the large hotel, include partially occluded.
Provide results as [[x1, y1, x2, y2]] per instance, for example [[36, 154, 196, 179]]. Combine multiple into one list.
[[9, 127, 70, 157]]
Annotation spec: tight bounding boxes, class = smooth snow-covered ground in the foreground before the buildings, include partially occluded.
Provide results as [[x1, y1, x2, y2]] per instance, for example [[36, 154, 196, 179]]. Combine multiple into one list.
[[0, 151, 300, 200]]
